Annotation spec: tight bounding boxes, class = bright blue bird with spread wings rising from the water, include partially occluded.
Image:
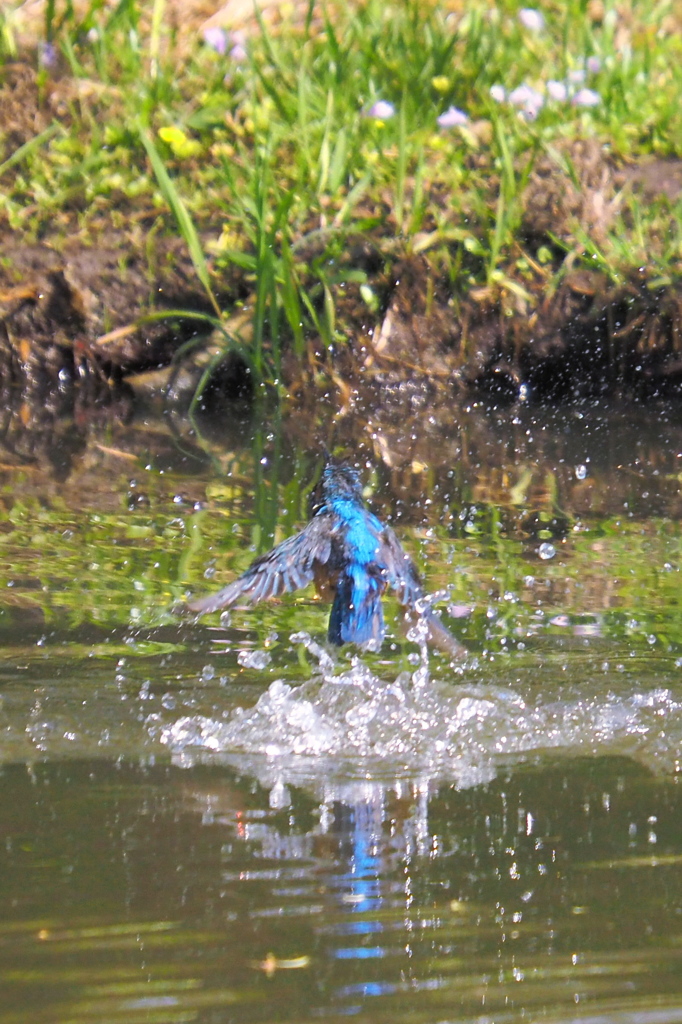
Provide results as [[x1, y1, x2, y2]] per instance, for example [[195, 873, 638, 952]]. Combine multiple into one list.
[[186, 461, 467, 659]]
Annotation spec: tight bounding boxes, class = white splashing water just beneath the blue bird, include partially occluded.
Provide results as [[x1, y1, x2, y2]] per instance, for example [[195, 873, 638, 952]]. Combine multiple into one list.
[[154, 622, 682, 787]]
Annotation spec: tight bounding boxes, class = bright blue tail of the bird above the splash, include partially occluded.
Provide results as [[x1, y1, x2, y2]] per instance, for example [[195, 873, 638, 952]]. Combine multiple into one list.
[[328, 568, 385, 646]]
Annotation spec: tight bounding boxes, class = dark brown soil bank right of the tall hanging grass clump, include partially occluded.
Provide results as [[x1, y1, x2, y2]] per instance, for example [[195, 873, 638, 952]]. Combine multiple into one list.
[[331, 249, 682, 403]]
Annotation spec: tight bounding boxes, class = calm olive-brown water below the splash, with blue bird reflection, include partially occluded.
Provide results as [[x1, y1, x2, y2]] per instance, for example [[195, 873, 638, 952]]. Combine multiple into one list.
[[0, 759, 682, 1024]]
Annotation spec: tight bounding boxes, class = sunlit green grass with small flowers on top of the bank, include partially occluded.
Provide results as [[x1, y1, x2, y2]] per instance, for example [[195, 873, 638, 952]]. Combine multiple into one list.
[[0, 0, 682, 379]]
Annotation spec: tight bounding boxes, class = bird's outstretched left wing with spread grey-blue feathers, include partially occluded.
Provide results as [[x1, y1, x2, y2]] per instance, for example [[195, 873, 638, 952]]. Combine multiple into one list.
[[187, 515, 333, 614]]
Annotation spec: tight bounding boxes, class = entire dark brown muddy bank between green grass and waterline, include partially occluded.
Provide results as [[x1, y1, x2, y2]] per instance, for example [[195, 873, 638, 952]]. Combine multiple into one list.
[[0, 228, 682, 403]]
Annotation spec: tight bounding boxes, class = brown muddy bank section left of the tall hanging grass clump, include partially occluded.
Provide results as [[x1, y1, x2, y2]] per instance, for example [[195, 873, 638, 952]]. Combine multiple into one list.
[[0, 229, 241, 394]]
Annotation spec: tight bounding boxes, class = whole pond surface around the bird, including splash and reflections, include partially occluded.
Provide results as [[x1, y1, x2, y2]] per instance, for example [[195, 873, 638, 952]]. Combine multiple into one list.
[[0, 389, 682, 1024]]
